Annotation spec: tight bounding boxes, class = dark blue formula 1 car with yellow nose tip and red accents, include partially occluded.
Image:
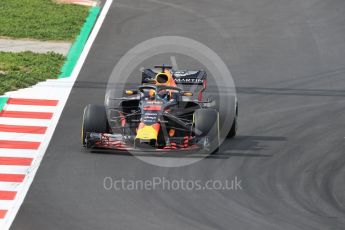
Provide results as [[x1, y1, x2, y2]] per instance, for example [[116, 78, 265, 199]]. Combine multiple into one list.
[[82, 65, 237, 153]]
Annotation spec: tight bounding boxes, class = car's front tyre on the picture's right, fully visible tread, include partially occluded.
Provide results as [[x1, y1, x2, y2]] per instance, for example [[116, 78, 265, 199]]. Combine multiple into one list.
[[194, 109, 220, 153]]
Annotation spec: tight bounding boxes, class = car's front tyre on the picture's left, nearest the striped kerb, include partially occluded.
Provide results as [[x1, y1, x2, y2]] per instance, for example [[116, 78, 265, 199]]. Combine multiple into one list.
[[81, 104, 109, 147]]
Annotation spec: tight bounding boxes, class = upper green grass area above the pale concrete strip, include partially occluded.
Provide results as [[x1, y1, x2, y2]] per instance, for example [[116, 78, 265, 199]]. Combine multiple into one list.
[[0, 0, 89, 41]]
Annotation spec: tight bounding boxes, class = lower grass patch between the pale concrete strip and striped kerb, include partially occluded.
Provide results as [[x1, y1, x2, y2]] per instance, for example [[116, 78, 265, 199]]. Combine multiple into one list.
[[0, 51, 65, 95]]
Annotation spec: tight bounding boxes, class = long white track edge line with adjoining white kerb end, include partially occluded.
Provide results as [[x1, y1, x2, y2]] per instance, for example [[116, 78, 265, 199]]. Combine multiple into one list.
[[0, 0, 113, 230]]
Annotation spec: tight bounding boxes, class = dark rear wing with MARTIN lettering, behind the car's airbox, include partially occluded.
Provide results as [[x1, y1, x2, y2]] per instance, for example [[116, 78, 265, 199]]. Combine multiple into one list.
[[141, 69, 207, 85]]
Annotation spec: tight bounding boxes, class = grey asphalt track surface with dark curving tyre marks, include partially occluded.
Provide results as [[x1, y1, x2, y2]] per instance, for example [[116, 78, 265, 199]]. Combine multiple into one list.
[[12, 0, 345, 230]]
